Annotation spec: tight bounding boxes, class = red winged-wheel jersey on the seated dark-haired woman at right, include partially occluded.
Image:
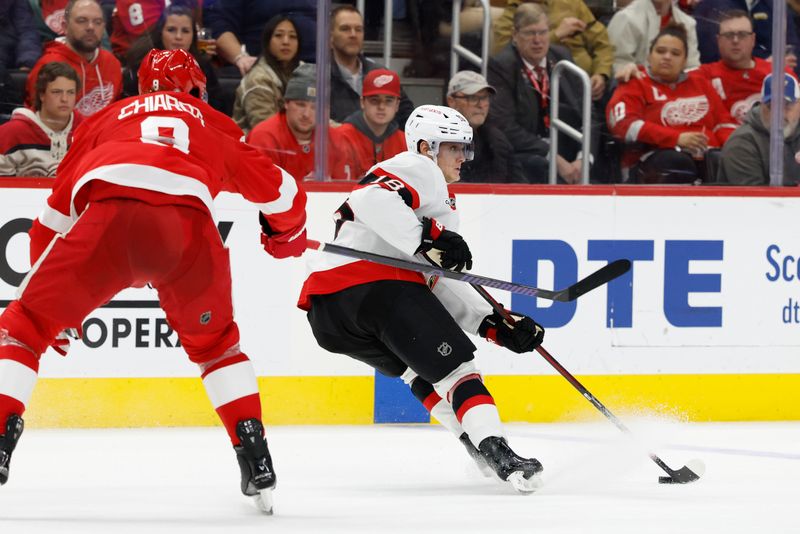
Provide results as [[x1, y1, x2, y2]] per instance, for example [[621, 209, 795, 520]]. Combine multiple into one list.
[[606, 70, 737, 167]]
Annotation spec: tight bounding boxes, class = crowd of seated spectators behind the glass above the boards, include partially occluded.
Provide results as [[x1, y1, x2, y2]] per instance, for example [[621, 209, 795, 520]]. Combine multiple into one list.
[[0, 0, 800, 186]]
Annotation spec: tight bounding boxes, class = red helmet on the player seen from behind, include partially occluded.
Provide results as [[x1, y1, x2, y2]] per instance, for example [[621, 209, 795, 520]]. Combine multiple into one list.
[[139, 48, 206, 100]]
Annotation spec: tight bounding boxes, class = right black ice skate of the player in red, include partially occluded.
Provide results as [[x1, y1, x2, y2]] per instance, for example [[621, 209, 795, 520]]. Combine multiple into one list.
[[233, 418, 277, 515]]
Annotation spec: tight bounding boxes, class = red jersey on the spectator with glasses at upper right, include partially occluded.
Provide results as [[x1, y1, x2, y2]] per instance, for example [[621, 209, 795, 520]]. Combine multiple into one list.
[[698, 57, 794, 124]]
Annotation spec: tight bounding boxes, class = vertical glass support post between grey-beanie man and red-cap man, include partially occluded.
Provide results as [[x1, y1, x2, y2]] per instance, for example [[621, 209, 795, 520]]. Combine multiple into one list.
[[314, 0, 331, 181]]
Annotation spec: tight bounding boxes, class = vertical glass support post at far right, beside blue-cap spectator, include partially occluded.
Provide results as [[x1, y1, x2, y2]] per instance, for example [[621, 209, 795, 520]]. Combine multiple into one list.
[[769, 2, 786, 186]]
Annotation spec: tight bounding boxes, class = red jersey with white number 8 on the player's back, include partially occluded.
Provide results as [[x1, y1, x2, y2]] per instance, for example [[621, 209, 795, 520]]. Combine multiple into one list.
[[30, 92, 306, 263]]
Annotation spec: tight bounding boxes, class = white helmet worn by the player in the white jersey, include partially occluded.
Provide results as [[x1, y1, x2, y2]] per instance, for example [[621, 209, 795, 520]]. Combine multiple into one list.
[[406, 105, 475, 161]]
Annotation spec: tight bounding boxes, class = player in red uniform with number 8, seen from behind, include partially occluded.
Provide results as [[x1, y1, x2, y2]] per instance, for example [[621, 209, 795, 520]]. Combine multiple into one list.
[[0, 49, 306, 511]]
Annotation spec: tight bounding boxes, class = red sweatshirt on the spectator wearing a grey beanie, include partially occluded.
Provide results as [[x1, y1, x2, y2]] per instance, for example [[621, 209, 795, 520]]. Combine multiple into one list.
[[247, 111, 357, 180]]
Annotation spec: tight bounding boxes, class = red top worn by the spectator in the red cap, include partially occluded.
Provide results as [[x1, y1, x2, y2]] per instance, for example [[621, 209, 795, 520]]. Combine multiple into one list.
[[337, 111, 406, 180]]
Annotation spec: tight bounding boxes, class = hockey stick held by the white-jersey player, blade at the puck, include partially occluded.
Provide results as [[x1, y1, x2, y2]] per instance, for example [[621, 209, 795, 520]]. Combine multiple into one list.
[[470, 284, 705, 484]]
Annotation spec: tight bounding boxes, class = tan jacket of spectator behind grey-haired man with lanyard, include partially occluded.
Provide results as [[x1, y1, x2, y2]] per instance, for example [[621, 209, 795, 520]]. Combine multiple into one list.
[[494, 0, 614, 100]]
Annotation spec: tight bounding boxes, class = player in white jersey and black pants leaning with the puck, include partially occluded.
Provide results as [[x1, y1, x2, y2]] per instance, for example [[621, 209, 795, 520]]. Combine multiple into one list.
[[298, 105, 544, 492]]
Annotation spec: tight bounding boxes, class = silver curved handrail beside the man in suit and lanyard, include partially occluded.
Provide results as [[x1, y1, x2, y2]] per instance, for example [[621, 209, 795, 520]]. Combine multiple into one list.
[[548, 60, 592, 184]]
